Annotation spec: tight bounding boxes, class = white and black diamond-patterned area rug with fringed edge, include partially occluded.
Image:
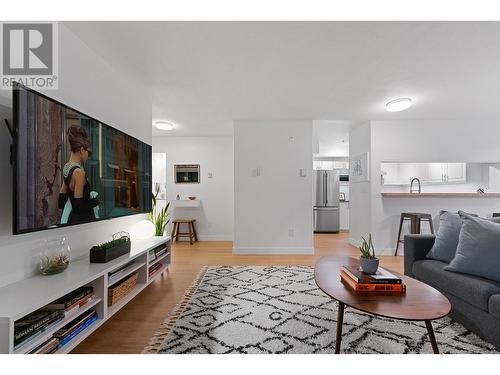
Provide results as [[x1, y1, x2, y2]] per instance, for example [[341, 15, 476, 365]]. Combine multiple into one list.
[[144, 266, 499, 354]]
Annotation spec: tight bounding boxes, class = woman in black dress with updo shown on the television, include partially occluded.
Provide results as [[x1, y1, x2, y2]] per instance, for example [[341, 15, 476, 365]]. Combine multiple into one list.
[[59, 125, 99, 224]]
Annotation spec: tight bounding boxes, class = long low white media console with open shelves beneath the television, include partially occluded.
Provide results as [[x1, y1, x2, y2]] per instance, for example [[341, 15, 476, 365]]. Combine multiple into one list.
[[0, 237, 170, 354]]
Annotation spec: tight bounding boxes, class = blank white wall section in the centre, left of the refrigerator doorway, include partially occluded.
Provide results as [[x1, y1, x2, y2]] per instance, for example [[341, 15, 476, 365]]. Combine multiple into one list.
[[233, 120, 314, 254]]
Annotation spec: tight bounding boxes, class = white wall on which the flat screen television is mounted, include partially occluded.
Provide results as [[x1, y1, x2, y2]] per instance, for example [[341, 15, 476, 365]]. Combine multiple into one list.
[[0, 24, 151, 286]]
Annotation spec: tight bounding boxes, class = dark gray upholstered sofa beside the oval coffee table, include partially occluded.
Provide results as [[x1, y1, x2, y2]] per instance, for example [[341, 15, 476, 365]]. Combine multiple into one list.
[[404, 234, 500, 348]]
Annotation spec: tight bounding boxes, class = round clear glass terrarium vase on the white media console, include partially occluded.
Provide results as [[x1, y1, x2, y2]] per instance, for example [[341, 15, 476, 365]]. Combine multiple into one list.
[[39, 237, 71, 275]]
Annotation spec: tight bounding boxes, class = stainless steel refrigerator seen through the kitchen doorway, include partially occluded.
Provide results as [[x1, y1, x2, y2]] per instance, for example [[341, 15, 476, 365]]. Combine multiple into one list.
[[313, 170, 340, 233]]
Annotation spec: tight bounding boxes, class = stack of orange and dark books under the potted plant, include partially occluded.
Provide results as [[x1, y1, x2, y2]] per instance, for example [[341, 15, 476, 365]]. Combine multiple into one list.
[[340, 266, 406, 295]]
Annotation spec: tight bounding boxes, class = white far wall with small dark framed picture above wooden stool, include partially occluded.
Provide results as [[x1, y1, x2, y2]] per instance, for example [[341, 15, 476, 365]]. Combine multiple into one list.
[[153, 137, 234, 241]]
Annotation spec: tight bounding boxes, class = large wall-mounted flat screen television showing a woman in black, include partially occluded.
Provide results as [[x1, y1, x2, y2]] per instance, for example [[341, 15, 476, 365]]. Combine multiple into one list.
[[13, 85, 152, 234]]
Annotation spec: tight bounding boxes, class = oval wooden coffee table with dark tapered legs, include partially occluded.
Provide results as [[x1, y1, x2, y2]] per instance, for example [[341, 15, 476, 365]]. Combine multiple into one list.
[[314, 256, 451, 354]]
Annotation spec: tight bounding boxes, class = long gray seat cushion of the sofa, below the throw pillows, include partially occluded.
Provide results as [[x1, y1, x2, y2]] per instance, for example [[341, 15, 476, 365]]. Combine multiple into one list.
[[412, 259, 500, 311]]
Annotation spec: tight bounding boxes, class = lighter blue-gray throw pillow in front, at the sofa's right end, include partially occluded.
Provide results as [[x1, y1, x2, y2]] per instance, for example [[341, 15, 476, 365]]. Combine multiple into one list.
[[444, 214, 500, 281]]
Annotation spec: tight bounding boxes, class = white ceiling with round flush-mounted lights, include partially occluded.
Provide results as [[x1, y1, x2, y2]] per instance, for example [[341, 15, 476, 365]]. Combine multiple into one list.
[[65, 22, 500, 136]]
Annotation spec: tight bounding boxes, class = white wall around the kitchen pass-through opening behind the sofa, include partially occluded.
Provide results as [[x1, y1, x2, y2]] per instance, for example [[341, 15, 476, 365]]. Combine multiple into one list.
[[350, 120, 500, 253]]
